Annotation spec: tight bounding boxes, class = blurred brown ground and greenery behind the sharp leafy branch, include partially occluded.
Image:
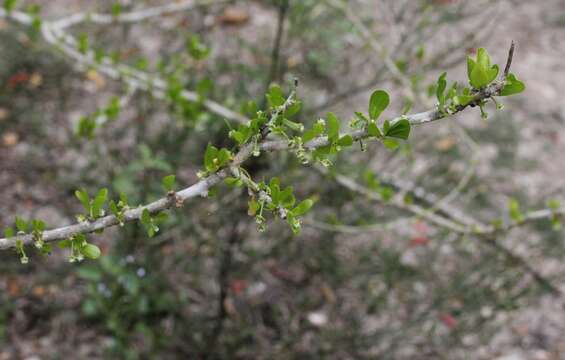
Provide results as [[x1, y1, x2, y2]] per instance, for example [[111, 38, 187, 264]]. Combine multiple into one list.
[[0, 0, 565, 360]]
